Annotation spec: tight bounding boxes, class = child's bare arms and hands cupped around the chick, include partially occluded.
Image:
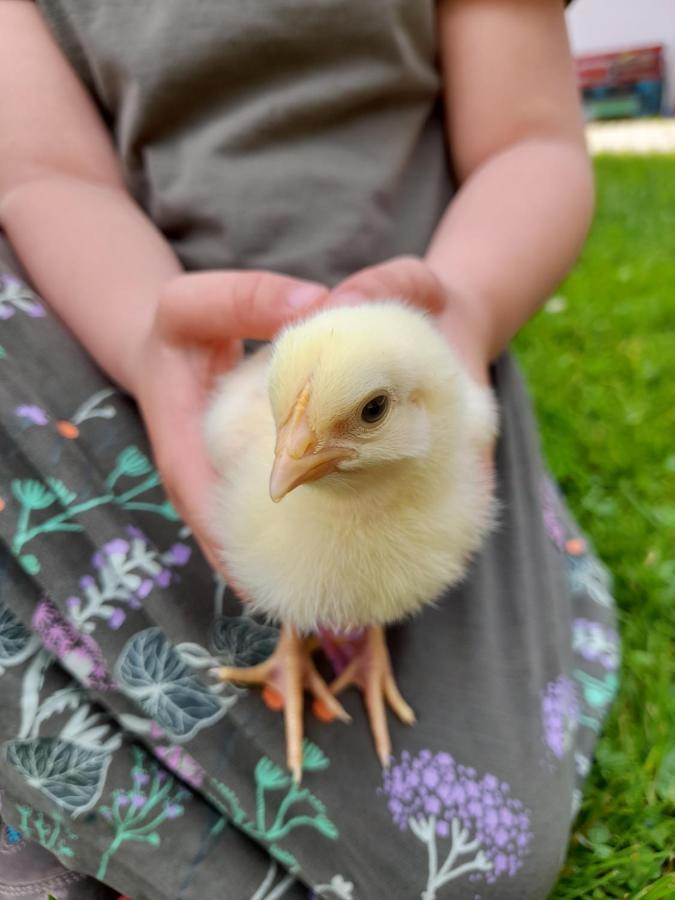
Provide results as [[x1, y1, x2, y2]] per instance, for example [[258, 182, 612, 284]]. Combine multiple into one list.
[[0, 0, 593, 562]]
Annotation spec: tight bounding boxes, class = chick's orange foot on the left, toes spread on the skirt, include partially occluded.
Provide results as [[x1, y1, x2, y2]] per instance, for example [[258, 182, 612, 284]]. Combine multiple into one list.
[[211, 625, 351, 783]]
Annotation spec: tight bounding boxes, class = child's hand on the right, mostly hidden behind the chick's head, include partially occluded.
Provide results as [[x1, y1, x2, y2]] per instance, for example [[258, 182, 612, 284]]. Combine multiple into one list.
[[331, 256, 490, 384]]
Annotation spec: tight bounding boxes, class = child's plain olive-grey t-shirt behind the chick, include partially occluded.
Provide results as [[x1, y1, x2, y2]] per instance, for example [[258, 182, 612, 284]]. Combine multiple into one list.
[[34, 0, 452, 284]]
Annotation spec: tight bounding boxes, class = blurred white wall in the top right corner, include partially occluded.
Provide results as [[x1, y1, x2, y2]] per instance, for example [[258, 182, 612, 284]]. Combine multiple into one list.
[[567, 0, 675, 112]]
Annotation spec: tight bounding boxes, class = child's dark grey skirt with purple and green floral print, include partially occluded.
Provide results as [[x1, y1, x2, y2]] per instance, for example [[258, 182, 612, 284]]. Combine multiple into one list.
[[0, 245, 619, 900]]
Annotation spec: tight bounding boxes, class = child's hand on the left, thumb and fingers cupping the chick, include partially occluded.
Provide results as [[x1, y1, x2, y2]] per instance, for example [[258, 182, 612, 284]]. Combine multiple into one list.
[[131, 272, 328, 568]]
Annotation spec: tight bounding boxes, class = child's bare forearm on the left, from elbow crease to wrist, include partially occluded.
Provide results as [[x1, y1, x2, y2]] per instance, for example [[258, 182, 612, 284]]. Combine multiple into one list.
[[0, 172, 181, 390]]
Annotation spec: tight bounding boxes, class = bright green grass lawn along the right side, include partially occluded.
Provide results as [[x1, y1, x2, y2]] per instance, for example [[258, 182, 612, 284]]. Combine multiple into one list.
[[516, 157, 675, 900]]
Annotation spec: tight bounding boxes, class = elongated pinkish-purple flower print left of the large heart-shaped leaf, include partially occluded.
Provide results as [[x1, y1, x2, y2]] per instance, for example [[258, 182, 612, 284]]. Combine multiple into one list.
[[32, 596, 114, 691]]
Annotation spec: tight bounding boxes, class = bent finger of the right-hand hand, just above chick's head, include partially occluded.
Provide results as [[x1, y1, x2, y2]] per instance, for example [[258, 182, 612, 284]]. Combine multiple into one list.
[[330, 256, 447, 315]]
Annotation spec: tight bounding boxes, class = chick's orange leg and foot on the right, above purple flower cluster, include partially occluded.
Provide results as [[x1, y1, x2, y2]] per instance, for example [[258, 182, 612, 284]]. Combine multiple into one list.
[[330, 625, 415, 768]]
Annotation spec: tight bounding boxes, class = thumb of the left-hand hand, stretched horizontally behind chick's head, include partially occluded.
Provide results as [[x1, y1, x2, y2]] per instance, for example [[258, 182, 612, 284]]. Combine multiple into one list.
[[157, 271, 328, 344]]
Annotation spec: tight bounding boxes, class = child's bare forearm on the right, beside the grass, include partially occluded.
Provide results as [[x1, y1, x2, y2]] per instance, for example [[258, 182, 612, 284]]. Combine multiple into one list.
[[427, 138, 593, 359]]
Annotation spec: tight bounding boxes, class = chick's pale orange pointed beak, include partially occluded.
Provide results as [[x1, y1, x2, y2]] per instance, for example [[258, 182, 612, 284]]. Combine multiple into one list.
[[270, 385, 354, 503]]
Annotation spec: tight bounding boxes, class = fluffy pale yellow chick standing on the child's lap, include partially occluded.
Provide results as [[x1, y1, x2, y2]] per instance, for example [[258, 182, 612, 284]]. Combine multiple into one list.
[[205, 301, 497, 780]]
